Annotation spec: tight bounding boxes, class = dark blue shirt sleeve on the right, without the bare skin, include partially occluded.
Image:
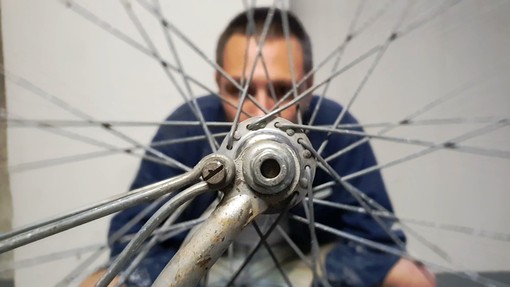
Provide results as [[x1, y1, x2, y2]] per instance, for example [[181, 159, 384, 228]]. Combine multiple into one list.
[[291, 98, 406, 287]]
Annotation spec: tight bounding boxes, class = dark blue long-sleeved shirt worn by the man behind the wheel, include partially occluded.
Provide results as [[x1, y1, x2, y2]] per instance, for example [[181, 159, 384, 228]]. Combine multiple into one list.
[[109, 95, 405, 286]]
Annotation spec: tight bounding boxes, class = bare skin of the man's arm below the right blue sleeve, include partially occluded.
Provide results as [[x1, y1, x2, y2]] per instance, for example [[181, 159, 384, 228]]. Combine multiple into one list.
[[383, 258, 436, 287]]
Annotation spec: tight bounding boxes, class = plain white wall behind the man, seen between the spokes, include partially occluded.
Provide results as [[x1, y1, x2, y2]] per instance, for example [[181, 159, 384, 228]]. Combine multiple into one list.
[[2, 0, 510, 286]]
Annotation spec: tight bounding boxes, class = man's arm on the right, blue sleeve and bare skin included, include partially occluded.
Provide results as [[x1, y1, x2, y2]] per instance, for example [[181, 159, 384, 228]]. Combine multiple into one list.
[[310, 98, 435, 286]]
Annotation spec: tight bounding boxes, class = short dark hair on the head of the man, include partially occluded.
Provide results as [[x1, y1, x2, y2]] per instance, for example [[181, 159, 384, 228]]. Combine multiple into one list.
[[216, 7, 313, 74]]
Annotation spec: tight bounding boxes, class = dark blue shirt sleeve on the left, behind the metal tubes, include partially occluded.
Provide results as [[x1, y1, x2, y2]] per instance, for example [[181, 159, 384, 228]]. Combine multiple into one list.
[[108, 102, 213, 286]]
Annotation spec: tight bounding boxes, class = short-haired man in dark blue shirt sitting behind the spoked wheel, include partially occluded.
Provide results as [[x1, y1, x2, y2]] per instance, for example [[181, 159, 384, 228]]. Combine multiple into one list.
[[83, 8, 434, 286]]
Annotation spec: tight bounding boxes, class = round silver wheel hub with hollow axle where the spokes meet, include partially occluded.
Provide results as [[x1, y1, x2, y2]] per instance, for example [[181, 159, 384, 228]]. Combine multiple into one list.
[[218, 118, 316, 213]]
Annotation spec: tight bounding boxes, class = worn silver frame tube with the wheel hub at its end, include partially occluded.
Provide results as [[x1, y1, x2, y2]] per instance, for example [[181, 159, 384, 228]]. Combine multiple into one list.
[[153, 118, 316, 287]]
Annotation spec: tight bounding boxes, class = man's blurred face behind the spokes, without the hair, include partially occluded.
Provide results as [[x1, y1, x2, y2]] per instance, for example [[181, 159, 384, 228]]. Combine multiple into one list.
[[216, 34, 311, 122]]
